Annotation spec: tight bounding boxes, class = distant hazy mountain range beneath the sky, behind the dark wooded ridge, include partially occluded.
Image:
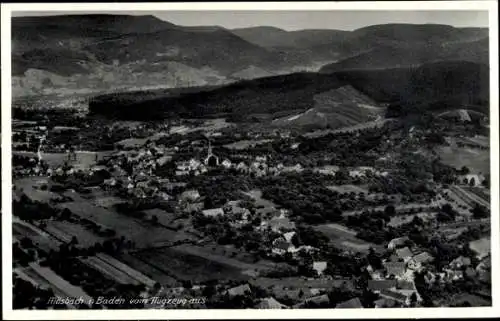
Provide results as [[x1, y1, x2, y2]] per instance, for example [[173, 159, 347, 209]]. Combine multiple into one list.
[[12, 15, 489, 97]]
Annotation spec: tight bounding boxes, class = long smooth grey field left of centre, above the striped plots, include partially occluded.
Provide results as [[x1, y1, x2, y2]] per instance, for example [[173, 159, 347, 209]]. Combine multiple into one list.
[[58, 202, 191, 248]]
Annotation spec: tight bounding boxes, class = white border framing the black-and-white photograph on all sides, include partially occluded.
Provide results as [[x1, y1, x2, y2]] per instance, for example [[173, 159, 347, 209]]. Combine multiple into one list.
[[1, 1, 500, 320]]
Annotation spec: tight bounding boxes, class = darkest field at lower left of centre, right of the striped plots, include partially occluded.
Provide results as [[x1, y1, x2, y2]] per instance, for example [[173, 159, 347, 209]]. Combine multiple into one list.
[[135, 248, 248, 283]]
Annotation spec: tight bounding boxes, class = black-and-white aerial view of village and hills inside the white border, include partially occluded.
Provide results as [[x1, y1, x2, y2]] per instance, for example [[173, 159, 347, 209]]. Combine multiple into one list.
[[9, 8, 492, 310]]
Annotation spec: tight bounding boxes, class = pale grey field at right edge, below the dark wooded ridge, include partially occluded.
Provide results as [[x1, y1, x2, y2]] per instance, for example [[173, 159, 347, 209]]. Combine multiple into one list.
[[436, 146, 490, 174]]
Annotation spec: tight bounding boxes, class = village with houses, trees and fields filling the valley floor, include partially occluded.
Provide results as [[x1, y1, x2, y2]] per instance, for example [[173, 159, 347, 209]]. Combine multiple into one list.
[[13, 114, 491, 309]]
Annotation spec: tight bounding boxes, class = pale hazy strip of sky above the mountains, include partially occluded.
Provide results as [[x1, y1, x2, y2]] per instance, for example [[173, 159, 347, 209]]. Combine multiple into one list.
[[13, 10, 488, 30]]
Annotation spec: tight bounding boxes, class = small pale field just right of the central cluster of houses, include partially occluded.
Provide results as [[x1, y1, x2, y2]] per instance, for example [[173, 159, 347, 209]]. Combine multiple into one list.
[[314, 224, 378, 252]]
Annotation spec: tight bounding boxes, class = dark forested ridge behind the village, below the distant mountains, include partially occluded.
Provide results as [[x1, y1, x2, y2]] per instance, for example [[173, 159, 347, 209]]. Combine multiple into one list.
[[90, 61, 489, 121]]
